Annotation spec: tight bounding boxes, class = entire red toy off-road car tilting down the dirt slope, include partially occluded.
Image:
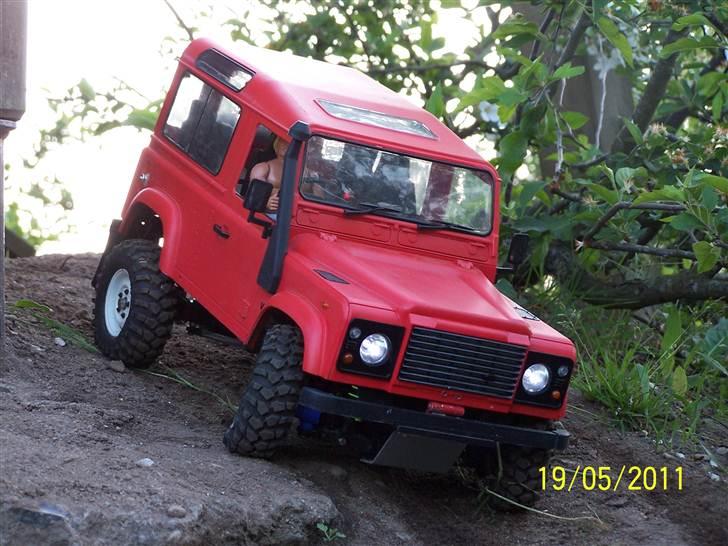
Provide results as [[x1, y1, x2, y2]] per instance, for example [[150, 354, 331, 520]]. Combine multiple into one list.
[[93, 39, 576, 504]]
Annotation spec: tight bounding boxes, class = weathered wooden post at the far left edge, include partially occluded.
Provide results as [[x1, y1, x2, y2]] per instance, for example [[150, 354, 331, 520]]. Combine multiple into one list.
[[0, 0, 28, 346]]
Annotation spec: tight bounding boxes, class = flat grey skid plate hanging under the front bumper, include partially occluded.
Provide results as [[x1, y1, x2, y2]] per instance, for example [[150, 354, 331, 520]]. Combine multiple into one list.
[[362, 428, 467, 474]]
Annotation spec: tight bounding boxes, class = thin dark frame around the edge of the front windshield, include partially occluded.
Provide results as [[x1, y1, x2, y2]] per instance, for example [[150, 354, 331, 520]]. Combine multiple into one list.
[[297, 132, 497, 238]]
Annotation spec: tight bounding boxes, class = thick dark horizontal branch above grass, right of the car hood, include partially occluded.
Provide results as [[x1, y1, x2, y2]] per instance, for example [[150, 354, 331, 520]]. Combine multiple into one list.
[[545, 243, 728, 309]]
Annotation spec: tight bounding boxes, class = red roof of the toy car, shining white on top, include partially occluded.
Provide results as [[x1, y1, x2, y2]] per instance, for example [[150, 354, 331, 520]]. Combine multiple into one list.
[[182, 38, 489, 168]]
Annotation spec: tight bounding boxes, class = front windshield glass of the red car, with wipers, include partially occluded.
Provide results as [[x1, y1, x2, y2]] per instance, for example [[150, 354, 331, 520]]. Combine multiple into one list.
[[300, 136, 493, 235]]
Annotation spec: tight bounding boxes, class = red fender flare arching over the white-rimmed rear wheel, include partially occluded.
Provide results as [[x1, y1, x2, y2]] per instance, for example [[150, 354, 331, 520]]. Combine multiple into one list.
[[119, 188, 182, 277]]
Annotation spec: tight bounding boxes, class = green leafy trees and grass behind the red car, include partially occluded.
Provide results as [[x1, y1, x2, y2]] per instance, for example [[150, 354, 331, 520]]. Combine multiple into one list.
[[9, 0, 728, 439]]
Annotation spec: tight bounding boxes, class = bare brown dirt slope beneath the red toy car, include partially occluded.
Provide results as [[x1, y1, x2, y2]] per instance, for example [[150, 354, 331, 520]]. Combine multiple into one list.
[[0, 255, 728, 545]]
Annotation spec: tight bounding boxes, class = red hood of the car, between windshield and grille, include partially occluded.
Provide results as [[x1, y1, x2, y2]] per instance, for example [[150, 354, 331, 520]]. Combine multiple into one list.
[[289, 234, 570, 343]]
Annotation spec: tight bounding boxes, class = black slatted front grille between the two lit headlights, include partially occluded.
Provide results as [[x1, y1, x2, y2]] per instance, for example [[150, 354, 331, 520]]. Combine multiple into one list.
[[399, 328, 526, 398]]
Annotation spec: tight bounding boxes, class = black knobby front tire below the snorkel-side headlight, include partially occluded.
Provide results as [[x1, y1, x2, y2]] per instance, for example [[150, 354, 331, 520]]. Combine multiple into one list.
[[223, 324, 303, 458]]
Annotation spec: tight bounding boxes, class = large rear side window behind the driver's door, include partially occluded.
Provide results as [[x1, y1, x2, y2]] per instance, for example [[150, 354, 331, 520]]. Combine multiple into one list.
[[164, 74, 240, 174]]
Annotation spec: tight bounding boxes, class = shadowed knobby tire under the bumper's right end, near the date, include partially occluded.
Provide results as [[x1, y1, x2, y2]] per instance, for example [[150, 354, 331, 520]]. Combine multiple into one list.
[[485, 445, 551, 512]]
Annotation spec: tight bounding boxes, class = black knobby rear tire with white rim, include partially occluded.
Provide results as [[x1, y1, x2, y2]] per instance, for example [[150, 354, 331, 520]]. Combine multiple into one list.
[[93, 239, 182, 368]]
